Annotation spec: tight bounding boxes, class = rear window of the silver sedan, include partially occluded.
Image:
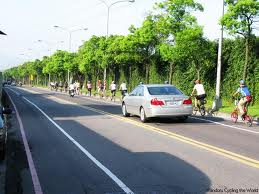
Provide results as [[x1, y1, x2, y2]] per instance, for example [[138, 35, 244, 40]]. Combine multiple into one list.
[[148, 86, 183, 95]]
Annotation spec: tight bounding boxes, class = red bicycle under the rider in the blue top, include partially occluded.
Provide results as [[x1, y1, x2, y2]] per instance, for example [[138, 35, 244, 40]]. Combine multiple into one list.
[[231, 98, 253, 127]]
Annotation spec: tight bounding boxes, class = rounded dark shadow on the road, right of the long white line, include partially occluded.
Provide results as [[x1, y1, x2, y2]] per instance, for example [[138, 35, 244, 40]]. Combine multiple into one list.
[[49, 120, 211, 194]]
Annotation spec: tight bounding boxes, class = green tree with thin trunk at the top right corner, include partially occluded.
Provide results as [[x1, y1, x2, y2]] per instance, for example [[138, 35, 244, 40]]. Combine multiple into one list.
[[221, 0, 259, 80]]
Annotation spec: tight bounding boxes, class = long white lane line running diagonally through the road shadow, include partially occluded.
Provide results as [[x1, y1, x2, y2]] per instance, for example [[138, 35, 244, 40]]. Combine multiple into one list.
[[23, 97, 134, 194]]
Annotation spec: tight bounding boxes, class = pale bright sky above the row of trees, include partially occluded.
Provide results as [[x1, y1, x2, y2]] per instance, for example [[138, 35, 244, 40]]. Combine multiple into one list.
[[0, 0, 222, 70]]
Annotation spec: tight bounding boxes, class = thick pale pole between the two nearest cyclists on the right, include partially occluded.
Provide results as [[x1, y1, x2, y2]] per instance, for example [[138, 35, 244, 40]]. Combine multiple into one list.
[[212, 0, 225, 111]]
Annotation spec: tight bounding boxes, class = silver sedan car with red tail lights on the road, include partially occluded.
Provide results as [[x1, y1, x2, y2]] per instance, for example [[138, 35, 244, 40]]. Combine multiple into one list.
[[122, 84, 192, 122]]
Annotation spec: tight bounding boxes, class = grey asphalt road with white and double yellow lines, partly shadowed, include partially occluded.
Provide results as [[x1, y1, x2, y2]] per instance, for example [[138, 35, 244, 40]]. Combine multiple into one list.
[[2, 87, 259, 194]]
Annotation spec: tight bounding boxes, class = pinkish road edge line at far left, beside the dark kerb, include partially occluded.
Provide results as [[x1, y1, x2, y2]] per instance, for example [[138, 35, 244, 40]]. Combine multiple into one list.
[[5, 89, 43, 194]]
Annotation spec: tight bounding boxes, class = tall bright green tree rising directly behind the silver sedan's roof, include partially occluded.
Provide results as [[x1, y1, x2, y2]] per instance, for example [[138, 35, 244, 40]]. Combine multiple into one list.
[[155, 0, 203, 83]]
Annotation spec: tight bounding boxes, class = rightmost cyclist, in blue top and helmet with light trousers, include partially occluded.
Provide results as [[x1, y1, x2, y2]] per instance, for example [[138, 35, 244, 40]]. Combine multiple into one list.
[[233, 80, 252, 117]]
